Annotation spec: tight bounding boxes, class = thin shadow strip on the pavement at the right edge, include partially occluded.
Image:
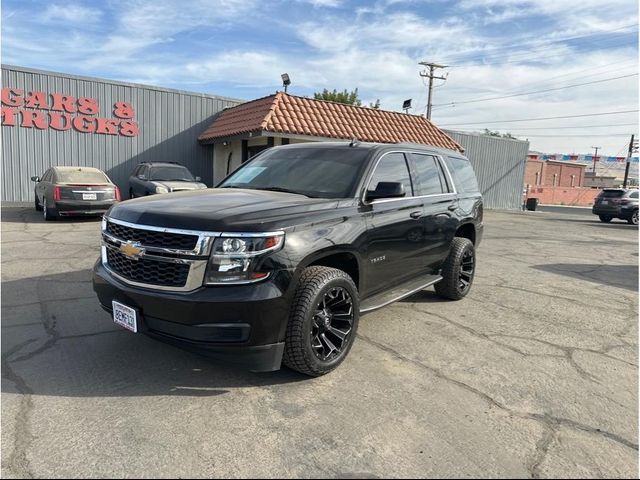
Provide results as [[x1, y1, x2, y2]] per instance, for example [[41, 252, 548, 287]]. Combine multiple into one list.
[[531, 263, 638, 292]]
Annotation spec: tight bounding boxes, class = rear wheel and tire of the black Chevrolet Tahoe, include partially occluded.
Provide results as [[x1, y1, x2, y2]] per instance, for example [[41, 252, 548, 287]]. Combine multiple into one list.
[[435, 237, 476, 300]]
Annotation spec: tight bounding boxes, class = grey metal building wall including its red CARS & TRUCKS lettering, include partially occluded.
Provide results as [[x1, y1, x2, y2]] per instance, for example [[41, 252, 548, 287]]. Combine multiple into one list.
[[2, 65, 241, 202]]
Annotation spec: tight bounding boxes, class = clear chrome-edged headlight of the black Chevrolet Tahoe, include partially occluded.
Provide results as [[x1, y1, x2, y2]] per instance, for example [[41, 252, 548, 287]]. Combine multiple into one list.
[[204, 233, 284, 285]]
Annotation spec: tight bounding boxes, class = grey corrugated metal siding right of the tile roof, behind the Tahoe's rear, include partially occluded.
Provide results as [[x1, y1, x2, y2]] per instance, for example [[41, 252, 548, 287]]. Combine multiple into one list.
[[445, 130, 529, 210]]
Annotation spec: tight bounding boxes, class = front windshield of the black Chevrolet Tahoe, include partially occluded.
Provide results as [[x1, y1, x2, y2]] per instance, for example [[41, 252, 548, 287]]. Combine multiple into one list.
[[219, 148, 369, 198]]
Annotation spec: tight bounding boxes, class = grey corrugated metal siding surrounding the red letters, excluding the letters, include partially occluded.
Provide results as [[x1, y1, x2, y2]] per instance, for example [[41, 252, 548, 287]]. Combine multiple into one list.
[[2, 65, 241, 202]]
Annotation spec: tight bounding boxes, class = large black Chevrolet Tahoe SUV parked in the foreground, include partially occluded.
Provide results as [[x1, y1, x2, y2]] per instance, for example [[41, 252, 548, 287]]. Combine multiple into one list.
[[93, 142, 483, 376]]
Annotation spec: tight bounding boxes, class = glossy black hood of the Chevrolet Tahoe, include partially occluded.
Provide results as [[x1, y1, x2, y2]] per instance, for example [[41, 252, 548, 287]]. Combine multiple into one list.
[[108, 188, 338, 232]]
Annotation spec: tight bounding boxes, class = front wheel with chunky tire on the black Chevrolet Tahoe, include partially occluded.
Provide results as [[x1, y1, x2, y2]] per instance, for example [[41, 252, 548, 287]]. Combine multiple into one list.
[[282, 266, 360, 377]]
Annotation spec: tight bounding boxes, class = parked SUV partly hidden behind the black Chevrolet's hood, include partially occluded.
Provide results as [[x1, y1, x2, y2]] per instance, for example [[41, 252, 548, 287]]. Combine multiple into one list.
[[129, 162, 207, 198]]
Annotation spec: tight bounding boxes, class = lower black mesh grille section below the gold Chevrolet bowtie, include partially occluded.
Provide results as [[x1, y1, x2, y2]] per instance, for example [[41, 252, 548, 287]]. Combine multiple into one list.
[[107, 248, 190, 287]]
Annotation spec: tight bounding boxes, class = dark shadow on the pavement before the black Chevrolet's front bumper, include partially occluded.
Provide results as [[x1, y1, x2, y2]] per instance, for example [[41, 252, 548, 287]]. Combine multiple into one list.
[[1, 270, 311, 397]]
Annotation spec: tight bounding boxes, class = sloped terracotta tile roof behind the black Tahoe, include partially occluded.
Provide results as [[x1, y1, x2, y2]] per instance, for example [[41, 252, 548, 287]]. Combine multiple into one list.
[[198, 92, 464, 151]]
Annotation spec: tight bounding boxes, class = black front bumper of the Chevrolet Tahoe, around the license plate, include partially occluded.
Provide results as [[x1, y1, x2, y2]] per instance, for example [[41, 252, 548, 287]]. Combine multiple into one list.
[[93, 261, 290, 372]]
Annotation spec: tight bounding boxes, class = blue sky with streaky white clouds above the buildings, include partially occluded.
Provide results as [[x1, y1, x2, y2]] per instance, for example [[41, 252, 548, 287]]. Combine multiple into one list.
[[1, 0, 639, 155]]
